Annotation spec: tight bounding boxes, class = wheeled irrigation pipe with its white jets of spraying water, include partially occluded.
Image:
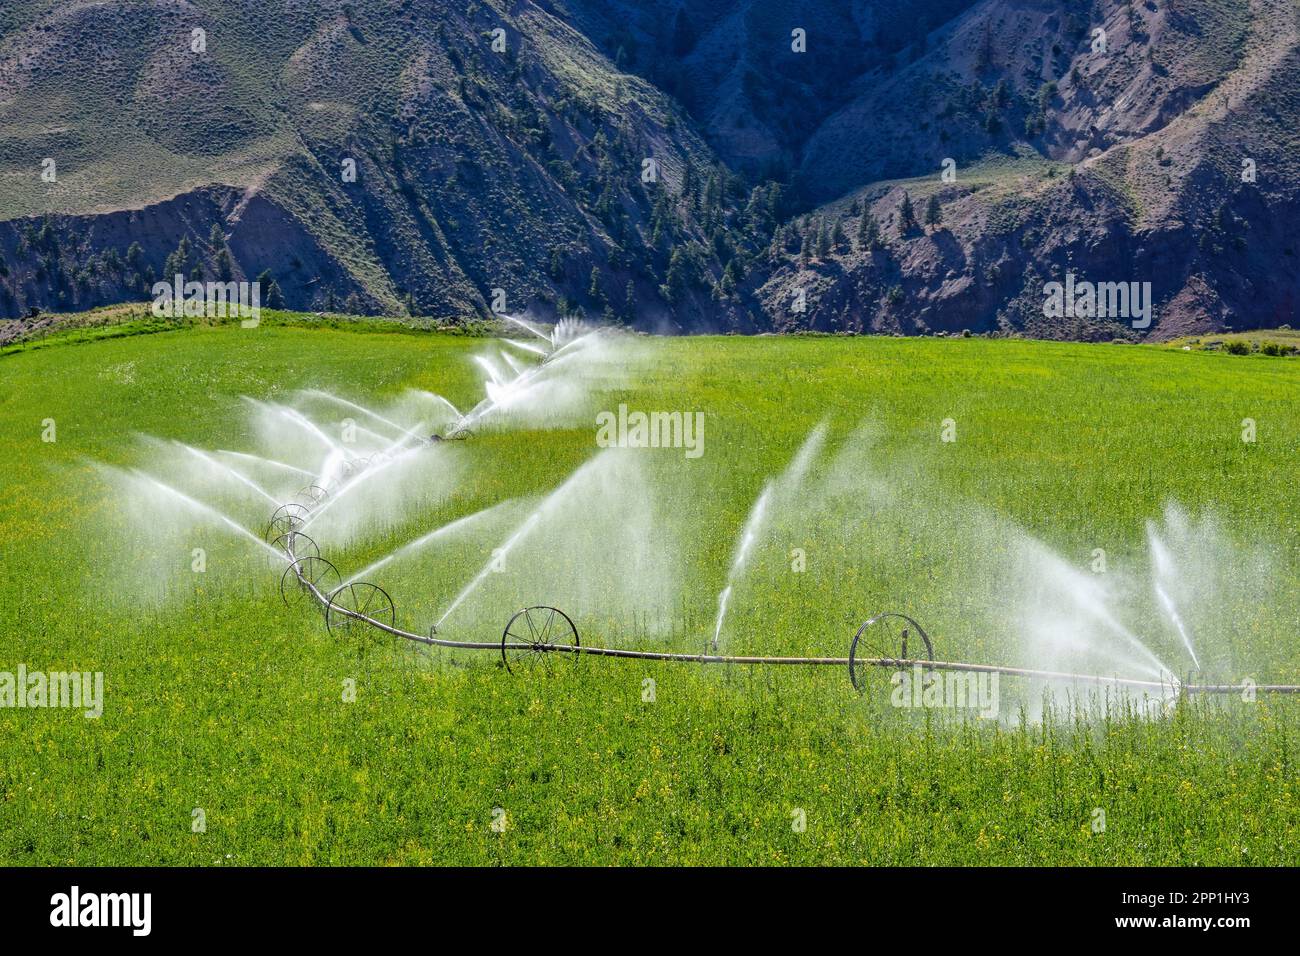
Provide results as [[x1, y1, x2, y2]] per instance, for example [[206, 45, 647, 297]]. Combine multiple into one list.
[[116, 332, 1300, 698]]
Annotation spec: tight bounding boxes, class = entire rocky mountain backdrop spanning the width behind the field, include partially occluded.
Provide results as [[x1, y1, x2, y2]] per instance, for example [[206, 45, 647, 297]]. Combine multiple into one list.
[[0, 0, 1300, 338]]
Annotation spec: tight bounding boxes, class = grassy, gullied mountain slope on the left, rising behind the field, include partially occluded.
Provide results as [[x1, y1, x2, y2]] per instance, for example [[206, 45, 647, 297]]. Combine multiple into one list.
[[0, 0, 738, 325]]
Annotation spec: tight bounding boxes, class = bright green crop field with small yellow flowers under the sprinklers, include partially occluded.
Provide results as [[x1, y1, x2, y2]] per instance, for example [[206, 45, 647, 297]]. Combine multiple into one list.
[[0, 326, 1300, 865]]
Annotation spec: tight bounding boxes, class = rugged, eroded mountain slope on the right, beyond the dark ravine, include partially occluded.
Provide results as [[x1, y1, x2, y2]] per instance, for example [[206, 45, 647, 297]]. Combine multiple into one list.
[[757, 0, 1300, 338]]
